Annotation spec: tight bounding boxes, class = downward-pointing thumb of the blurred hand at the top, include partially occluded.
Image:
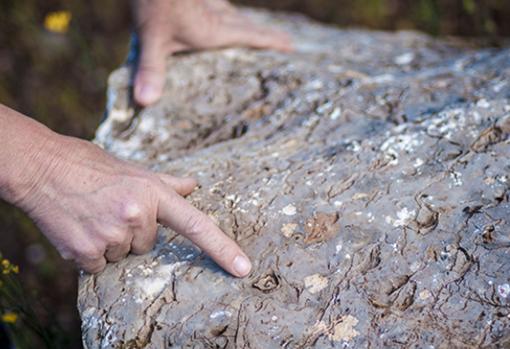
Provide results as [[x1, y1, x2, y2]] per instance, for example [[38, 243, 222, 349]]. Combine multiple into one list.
[[134, 37, 168, 106]]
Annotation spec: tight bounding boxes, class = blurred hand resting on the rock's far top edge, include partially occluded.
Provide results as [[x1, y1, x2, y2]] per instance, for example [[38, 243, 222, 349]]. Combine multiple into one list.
[[131, 0, 291, 106]]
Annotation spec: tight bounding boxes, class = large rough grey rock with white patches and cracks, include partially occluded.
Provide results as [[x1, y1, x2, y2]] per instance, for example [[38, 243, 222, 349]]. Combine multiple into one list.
[[79, 8, 510, 348]]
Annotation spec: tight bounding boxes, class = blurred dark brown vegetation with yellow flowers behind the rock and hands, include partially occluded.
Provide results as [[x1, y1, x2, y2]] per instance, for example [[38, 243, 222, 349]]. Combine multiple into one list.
[[0, 0, 510, 348]]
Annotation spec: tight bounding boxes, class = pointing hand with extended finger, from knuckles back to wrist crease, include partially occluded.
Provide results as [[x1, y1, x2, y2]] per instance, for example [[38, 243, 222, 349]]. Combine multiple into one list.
[[17, 135, 251, 277]]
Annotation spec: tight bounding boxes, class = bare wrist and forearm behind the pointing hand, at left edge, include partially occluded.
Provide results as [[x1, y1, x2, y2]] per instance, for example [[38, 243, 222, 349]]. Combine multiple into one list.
[[0, 104, 59, 206]]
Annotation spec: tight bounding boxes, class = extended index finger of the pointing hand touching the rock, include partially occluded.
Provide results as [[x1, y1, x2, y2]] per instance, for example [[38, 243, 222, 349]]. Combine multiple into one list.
[[158, 191, 251, 277]]
